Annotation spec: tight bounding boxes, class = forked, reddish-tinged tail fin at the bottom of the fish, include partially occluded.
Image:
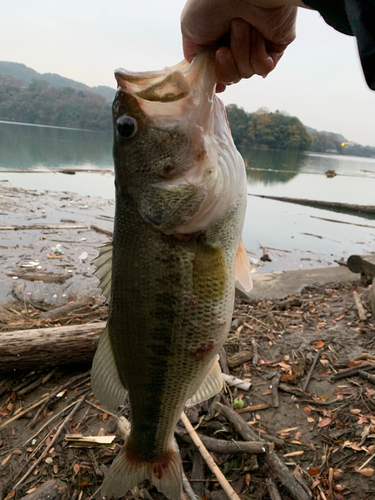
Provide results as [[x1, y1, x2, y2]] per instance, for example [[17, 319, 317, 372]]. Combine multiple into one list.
[[102, 444, 182, 500]]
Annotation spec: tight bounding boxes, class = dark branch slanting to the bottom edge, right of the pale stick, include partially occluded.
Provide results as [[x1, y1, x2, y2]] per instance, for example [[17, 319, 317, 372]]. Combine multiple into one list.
[[217, 403, 311, 500]]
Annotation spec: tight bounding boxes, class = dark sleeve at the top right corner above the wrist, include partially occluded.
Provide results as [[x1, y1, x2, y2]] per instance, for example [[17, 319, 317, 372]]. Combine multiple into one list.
[[303, 0, 375, 90]]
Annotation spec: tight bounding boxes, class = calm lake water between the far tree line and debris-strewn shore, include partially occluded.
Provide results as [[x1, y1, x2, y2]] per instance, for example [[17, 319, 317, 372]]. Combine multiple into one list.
[[0, 122, 375, 272]]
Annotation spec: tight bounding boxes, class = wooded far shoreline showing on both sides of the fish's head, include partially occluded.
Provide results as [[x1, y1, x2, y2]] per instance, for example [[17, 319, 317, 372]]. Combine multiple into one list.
[[0, 74, 375, 157]]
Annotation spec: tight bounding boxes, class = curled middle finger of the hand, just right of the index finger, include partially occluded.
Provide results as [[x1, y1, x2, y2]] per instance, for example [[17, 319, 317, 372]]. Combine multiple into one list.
[[230, 19, 255, 78]]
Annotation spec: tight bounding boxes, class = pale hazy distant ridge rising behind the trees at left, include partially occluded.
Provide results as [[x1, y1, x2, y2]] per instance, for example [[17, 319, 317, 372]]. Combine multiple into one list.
[[0, 61, 116, 102]]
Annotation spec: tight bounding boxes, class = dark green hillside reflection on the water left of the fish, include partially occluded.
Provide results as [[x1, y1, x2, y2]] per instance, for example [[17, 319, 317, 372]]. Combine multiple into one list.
[[0, 122, 113, 170]]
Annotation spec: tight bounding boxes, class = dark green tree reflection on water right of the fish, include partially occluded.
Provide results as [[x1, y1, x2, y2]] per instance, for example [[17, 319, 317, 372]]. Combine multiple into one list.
[[240, 148, 308, 186]]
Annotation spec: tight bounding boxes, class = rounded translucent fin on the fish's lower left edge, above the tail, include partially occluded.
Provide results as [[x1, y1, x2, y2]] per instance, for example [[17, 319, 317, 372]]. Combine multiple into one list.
[[91, 326, 128, 410]]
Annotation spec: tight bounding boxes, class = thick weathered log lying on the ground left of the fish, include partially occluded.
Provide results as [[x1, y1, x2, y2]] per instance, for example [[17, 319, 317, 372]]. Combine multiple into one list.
[[0, 321, 105, 373]]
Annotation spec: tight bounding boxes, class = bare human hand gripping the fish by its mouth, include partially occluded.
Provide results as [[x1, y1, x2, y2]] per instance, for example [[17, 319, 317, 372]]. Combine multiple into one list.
[[181, 0, 303, 92]]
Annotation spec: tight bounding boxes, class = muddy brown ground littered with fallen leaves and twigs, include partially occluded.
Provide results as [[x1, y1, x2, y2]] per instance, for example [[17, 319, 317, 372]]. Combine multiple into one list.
[[0, 281, 375, 500]]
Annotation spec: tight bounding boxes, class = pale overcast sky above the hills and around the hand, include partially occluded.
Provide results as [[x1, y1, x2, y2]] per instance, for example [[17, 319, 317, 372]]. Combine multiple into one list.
[[0, 0, 375, 146]]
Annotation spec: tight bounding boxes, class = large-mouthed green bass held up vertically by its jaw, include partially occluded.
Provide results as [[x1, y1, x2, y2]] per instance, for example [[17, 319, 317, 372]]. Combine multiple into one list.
[[92, 51, 251, 500]]
